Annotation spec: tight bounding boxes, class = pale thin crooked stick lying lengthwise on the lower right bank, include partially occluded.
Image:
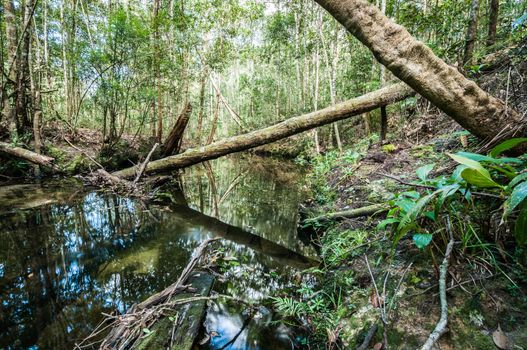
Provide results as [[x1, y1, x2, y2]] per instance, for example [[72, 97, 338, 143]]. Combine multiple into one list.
[[421, 216, 454, 350]]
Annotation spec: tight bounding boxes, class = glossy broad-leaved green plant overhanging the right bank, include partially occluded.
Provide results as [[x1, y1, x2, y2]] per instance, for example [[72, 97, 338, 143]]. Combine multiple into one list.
[[378, 139, 527, 248]]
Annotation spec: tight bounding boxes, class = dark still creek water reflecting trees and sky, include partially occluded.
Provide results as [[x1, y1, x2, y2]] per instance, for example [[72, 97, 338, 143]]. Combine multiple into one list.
[[0, 157, 314, 349]]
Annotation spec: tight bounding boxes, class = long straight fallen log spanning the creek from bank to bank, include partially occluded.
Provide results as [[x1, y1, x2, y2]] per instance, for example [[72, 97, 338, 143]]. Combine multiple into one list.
[[113, 83, 415, 178]]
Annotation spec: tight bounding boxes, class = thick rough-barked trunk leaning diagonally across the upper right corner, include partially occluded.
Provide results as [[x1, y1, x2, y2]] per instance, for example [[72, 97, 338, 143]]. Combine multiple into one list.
[[316, 0, 527, 143]]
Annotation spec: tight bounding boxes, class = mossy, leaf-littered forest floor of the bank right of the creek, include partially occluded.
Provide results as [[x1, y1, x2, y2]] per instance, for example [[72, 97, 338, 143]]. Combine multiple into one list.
[[284, 53, 527, 349]]
